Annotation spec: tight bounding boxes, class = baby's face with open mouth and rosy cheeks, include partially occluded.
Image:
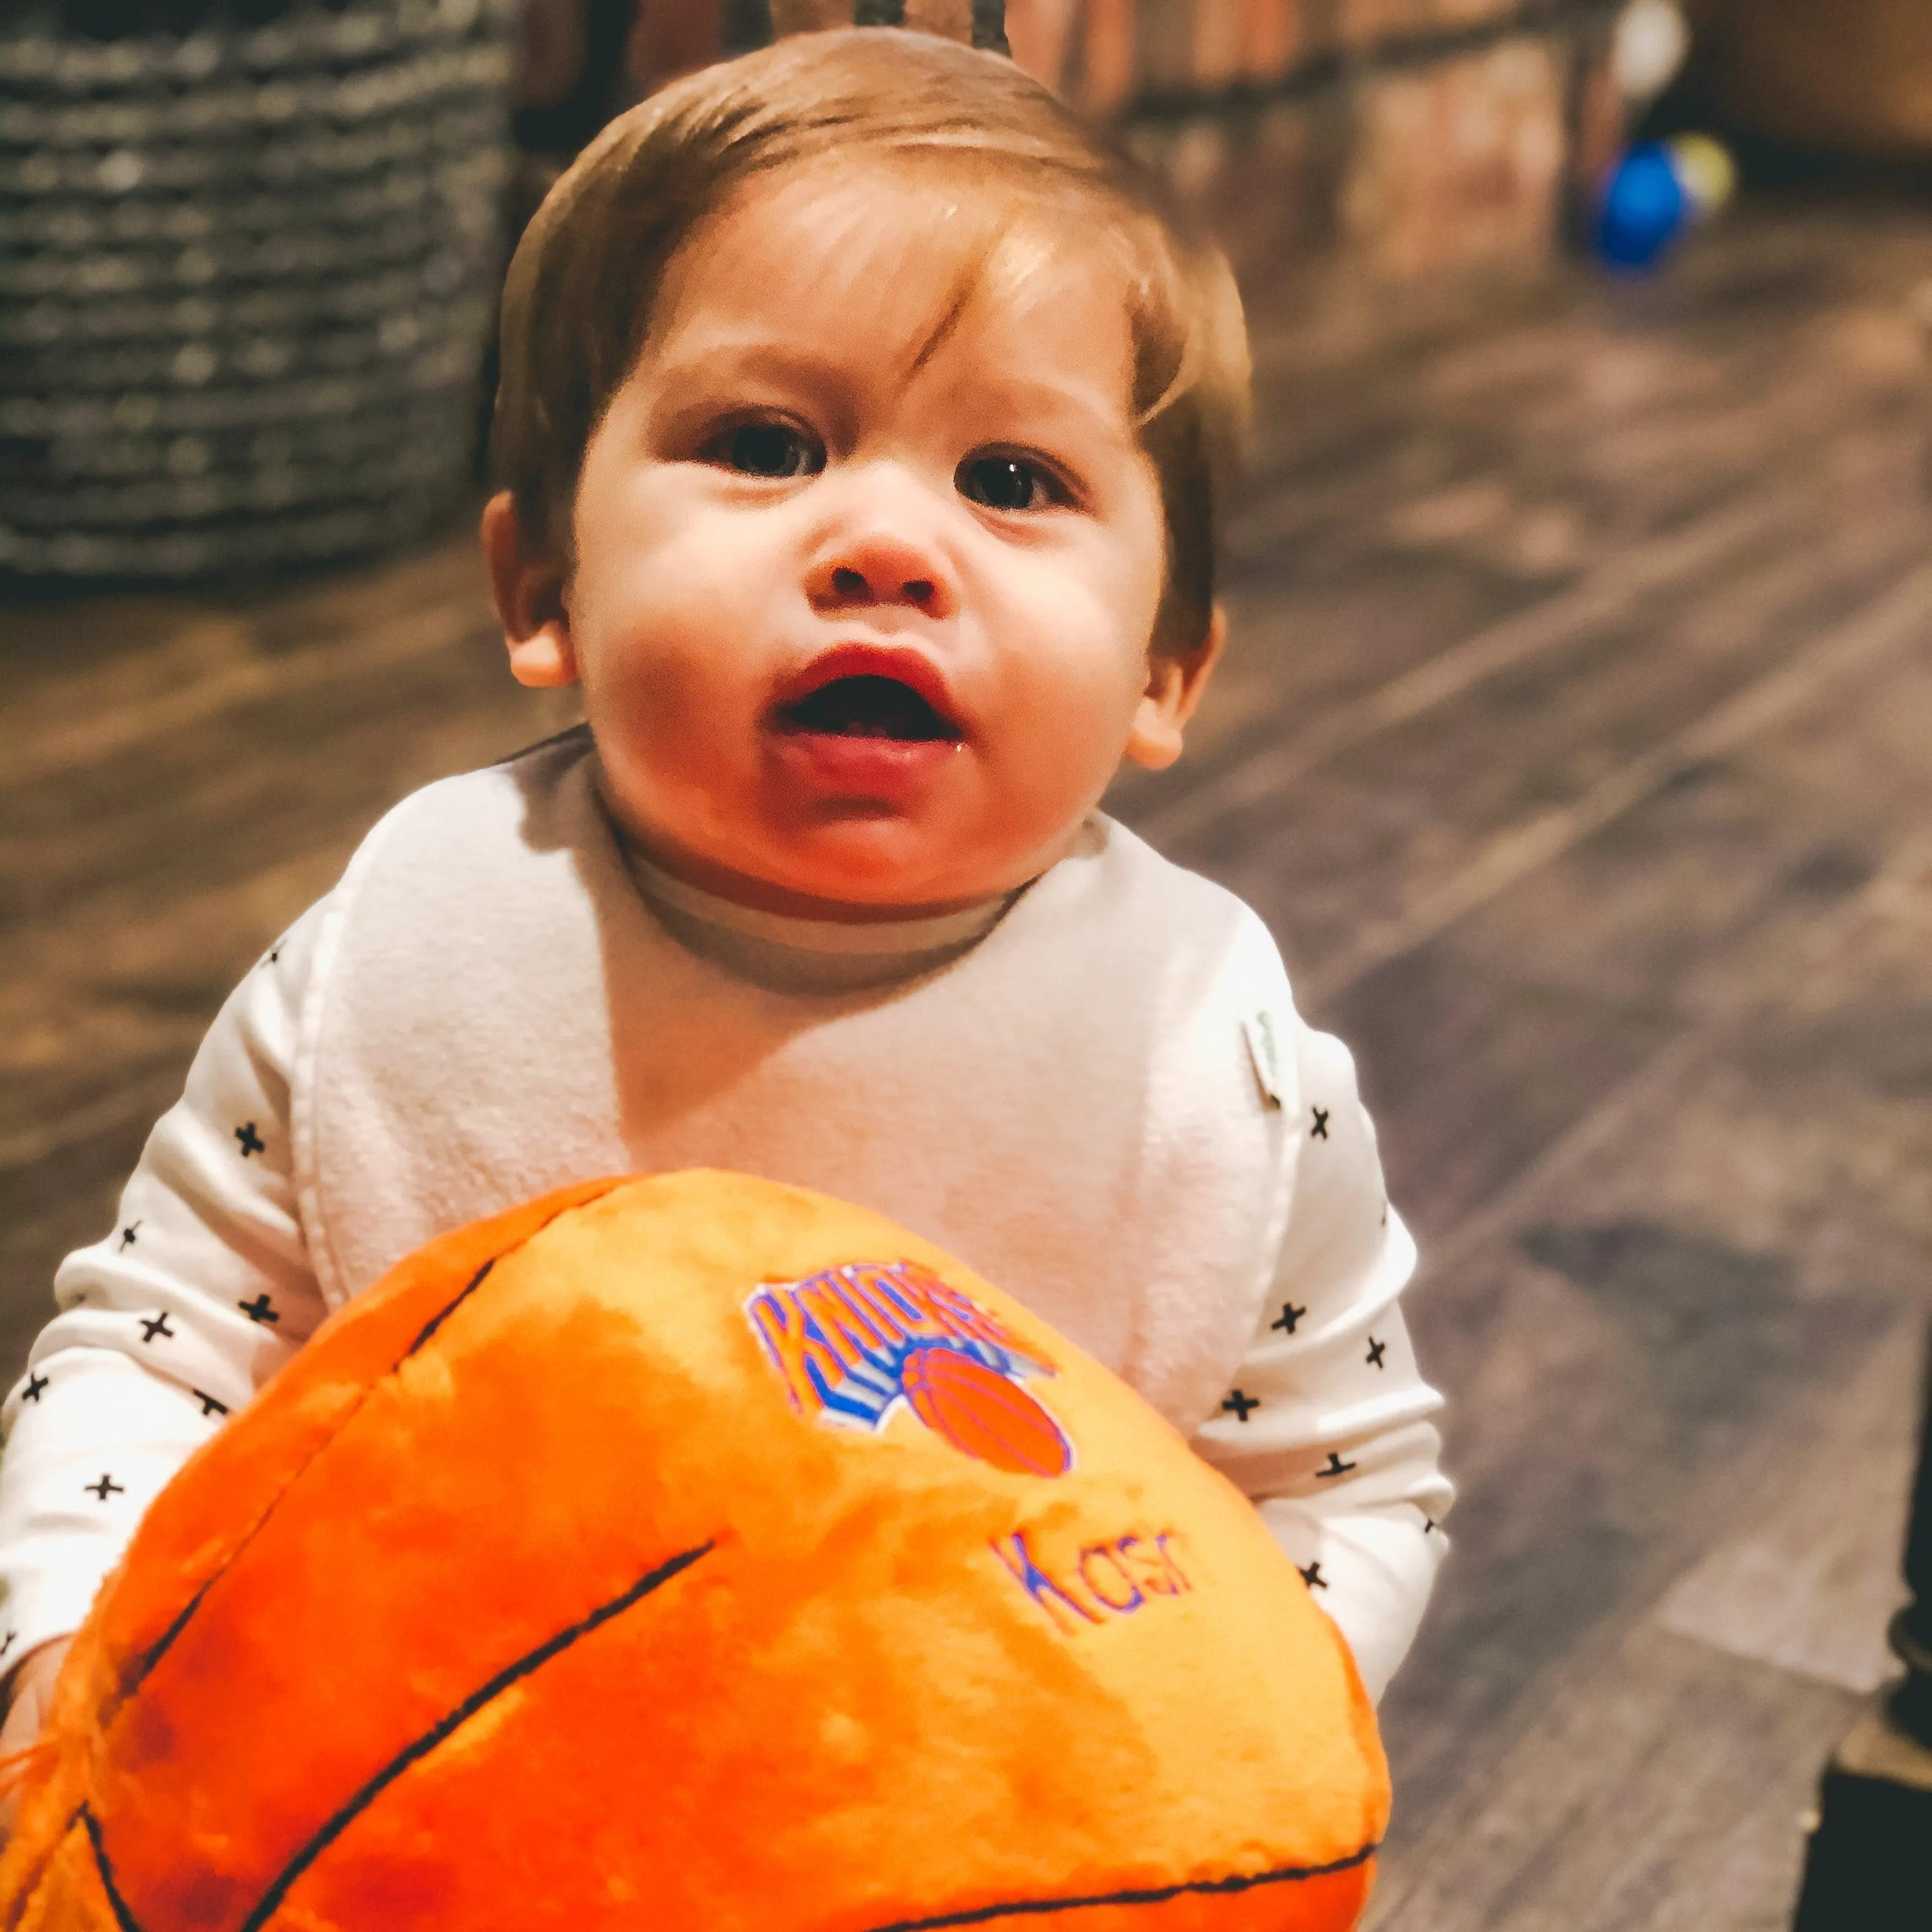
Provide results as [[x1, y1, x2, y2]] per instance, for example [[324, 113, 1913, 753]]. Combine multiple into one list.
[[512, 172, 1190, 916]]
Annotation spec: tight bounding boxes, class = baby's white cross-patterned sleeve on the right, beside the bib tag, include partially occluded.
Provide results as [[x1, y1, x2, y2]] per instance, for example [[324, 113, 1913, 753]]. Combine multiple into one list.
[[1194, 1022, 1453, 1698]]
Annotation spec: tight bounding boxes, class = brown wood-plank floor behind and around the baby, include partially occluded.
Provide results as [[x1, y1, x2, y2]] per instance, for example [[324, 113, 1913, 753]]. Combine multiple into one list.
[[0, 188, 1932, 1932]]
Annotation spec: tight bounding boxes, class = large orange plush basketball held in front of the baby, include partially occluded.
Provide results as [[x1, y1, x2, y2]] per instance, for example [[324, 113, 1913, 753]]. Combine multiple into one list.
[[0, 1173, 1387, 1932]]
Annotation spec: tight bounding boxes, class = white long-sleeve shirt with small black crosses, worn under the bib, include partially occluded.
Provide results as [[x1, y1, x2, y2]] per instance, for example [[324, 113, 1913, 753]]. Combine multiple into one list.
[[0, 746, 1451, 1694]]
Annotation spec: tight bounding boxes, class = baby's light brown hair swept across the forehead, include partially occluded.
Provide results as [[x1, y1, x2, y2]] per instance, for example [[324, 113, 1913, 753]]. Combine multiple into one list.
[[491, 27, 1248, 651]]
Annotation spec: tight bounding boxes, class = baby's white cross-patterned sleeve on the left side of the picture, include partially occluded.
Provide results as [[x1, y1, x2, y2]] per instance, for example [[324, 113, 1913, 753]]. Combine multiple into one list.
[[0, 900, 326, 1690]]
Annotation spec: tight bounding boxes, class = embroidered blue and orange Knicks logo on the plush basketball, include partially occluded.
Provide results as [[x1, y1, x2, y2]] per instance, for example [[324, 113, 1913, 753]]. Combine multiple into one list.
[[744, 1262, 1074, 1476]]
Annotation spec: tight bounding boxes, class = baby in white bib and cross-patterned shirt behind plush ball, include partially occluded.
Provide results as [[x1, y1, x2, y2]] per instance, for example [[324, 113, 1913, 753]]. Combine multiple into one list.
[[0, 29, 1449, 1749]]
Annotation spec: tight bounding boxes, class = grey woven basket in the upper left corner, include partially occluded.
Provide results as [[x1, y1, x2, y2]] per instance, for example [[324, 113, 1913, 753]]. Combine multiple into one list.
[[0, 0, 516, 578]]
